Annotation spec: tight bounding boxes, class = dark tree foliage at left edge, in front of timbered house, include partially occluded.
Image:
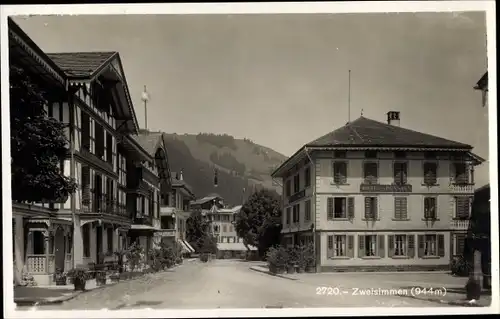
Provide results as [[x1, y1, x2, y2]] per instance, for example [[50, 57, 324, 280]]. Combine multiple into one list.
[[10, 65, 76, 203]]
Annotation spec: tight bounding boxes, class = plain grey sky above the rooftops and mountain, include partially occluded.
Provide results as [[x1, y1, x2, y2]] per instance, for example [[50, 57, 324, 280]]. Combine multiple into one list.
[[15, 13, 488, 185]]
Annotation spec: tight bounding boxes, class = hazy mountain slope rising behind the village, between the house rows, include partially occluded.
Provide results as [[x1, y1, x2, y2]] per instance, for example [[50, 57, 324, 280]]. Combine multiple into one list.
[[160, 134, 286, 205]]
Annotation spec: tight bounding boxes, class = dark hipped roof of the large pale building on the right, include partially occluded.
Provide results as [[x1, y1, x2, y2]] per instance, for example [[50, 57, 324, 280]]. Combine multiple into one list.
[[306, 116, 472, 149]]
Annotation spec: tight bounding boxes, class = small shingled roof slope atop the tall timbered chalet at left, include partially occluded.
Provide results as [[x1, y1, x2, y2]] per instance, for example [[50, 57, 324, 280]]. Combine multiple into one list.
[[47, 52, 118, 78]]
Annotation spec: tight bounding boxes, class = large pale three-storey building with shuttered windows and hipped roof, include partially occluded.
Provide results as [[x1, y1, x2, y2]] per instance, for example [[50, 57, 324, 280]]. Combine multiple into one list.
[[272, 112, 483, 271]]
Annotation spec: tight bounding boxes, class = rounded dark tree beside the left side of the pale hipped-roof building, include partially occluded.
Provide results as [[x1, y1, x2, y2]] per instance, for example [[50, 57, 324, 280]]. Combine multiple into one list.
[[235, 189, 282, 256]]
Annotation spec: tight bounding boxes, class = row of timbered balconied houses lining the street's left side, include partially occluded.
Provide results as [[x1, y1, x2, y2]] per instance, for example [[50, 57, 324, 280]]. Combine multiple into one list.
[[8, 19, 195, 285]]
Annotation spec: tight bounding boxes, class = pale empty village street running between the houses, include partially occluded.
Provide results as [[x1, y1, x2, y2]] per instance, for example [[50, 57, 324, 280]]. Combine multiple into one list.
[[19, 260, 470, 310]]
